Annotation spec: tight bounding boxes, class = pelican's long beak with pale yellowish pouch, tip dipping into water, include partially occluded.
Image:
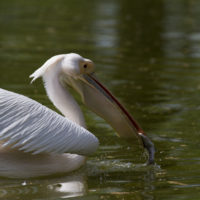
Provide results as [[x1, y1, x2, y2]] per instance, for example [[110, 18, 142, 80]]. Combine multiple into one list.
[[64, 74, 155, 163]]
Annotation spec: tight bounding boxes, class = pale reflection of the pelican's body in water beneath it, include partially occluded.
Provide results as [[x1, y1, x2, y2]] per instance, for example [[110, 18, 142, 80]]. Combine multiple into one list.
[[0, 172, 87, 200]]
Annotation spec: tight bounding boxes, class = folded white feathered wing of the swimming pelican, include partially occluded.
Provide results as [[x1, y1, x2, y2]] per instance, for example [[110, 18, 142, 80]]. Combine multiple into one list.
[[0, 89, 98, 155]]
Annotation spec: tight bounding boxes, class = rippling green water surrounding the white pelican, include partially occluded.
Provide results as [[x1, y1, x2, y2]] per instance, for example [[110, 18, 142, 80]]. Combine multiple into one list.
[[0, 0, 200, 200]]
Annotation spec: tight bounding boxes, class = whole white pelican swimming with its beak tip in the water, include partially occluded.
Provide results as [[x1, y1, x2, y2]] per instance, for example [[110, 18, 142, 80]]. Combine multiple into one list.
[[0, 53, 154, 178]]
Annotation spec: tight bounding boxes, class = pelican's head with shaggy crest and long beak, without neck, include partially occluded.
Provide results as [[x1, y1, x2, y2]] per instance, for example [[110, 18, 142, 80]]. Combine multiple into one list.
[[30, 53, 154, 163]]
